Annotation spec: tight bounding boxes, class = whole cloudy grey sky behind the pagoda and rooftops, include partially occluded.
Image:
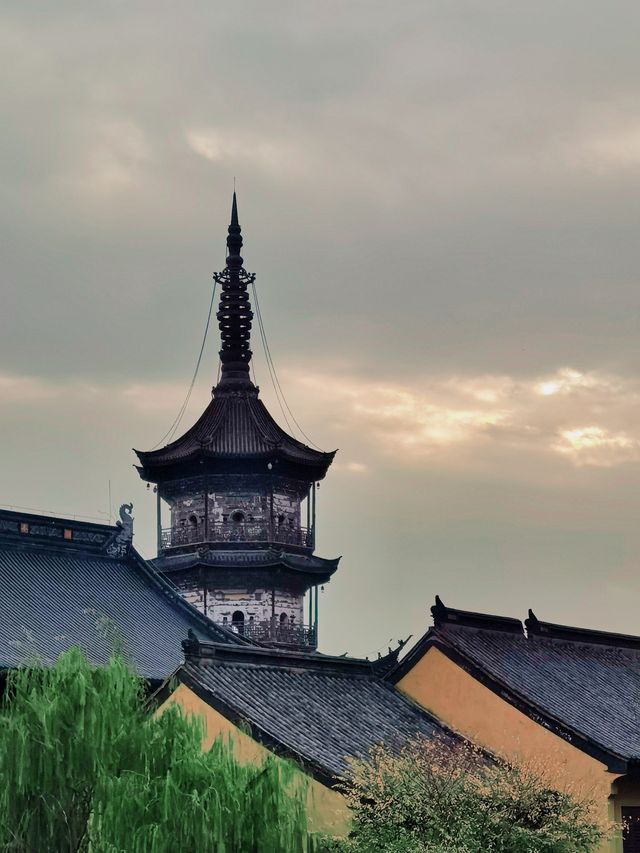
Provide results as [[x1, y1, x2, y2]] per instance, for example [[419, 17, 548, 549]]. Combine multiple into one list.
[[0, 0, 640, 654]]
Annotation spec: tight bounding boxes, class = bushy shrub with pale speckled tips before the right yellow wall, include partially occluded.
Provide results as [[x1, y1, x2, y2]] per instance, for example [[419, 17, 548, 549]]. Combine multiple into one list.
[[325, 739, 604, 853]]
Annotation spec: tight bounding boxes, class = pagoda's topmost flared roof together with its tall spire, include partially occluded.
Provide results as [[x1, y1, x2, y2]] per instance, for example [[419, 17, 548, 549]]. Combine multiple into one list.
[[135, 192, 335, 482]]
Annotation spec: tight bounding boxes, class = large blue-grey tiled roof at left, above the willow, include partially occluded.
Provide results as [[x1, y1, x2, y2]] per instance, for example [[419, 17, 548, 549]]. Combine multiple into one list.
[[0, 511, 242, 679]]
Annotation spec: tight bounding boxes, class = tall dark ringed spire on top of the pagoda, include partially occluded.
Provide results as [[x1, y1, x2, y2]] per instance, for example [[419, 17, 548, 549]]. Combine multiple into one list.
[[213, 190, 256, 393]]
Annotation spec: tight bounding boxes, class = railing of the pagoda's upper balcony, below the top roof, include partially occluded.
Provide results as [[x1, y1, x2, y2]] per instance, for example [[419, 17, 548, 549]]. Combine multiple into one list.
[[161, 521, 313, 551]]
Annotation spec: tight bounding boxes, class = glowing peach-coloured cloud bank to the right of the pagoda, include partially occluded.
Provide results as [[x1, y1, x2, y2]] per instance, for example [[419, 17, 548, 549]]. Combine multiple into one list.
[[290, 368, 640, 467]]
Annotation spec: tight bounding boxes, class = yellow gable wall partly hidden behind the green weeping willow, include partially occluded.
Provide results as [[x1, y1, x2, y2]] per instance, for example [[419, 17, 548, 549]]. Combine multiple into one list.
[[158, 684, 350, 836]]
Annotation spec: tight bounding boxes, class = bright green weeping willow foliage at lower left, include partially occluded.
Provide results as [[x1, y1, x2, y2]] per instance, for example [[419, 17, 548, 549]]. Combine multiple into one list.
[[0, 649, 312, 853]]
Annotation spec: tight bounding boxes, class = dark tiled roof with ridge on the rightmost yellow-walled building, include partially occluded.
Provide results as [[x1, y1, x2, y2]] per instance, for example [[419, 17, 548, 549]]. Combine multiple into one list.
[[392, 599, 640, 772]]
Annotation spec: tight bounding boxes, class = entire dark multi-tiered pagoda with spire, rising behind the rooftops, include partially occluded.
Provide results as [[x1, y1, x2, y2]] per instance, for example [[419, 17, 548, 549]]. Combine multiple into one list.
[[135, 192, 339, 649]]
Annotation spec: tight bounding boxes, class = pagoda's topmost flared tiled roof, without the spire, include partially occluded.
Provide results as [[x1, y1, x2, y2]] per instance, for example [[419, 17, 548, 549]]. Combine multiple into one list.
[[135, 388, 335, 476]]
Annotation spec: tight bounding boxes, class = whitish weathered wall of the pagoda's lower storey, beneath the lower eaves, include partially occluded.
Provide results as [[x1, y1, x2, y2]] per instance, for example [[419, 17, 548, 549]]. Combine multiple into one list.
[[171, 574, 304, 625]]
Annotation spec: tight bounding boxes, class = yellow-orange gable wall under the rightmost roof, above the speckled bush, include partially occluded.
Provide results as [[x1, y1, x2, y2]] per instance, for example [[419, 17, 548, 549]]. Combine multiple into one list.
[[397, 647, 624, 853]]
